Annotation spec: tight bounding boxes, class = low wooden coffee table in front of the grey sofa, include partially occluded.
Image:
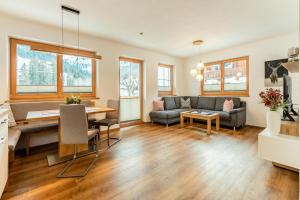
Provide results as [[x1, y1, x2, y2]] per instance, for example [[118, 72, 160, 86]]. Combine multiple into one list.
[[180, 111, 220, 134]]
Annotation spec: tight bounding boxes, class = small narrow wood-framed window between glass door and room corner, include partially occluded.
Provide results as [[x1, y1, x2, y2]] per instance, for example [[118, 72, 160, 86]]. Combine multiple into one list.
[[158, 64, 173, 96]]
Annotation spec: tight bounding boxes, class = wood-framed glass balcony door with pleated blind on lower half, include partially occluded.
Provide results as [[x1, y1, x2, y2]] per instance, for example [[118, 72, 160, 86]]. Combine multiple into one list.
[[119, 57, 143, 122]]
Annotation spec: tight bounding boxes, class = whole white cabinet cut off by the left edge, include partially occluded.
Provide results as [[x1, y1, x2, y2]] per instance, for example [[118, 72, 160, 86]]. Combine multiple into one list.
[[0, 109, 8, 198]]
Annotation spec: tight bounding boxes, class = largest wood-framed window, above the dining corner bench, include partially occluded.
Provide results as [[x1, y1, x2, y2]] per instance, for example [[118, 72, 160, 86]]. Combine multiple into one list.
[[10, 38, 96, 100]]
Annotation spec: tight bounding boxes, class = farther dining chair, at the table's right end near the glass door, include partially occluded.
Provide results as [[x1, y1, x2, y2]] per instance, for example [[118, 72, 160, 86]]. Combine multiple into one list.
[[92, 99, 121, 147]]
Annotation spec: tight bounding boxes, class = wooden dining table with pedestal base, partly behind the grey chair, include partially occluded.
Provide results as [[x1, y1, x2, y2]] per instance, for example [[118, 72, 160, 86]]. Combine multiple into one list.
[[26, 107, 116, 166]]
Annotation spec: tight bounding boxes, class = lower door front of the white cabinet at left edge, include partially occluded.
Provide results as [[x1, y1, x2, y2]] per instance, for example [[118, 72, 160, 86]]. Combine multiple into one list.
[[0, 137, 8, 198]]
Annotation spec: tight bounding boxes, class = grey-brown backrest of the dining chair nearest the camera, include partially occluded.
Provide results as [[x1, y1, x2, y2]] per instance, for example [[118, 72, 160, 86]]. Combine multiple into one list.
[[59, 105, 88, 144]]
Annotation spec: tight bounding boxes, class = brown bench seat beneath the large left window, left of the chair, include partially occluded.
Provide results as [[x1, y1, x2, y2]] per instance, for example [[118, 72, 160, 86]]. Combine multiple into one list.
[[16, 120, 58, 133]]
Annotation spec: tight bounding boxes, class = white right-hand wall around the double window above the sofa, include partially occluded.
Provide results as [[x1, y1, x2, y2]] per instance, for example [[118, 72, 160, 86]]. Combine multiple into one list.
[[184, 32, 299, 127]]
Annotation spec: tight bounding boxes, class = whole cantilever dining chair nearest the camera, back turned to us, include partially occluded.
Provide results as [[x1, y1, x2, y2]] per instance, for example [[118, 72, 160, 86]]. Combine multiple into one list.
[[57, 105, 99, 178]]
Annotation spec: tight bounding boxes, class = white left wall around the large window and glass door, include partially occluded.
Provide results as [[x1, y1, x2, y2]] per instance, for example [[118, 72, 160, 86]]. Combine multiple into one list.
[[0, 14, 184, 121]]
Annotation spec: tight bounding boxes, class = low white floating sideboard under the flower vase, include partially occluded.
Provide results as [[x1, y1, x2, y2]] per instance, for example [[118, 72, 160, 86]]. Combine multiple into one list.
[[258, 129, 300, 169]]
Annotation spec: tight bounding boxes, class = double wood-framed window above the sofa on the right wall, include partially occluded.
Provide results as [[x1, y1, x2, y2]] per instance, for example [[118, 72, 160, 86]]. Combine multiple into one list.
[[201, 57, 249, 96]]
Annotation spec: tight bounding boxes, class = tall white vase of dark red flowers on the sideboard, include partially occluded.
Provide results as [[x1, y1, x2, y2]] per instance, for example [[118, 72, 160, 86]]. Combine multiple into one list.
[[259, 88, 286, 134]]
